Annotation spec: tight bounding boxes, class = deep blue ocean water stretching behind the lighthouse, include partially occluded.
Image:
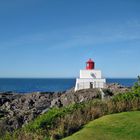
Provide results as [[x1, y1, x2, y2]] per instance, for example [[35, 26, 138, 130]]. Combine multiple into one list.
[[0, 78, 137, 93]]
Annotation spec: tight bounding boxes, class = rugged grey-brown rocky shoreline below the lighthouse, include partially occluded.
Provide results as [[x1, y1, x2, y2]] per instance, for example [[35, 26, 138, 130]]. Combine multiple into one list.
[[0, 83, 130, 135]]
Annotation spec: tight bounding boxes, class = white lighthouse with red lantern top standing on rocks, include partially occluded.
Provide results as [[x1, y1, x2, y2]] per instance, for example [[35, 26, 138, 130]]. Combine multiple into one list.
[[75, 59, 106, 91]]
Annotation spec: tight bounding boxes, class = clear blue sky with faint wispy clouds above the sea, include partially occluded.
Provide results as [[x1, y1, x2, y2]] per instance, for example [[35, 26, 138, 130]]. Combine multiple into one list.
[[0, 0, 140, 78]]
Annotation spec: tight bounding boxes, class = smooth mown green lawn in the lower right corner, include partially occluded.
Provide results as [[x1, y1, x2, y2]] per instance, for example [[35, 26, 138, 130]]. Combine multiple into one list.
[[64, 111, 140, 140]]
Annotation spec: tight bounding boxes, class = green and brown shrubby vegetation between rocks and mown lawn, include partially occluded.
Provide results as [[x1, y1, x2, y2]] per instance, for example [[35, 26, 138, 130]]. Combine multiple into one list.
[[3, 79, 140, 140]]
